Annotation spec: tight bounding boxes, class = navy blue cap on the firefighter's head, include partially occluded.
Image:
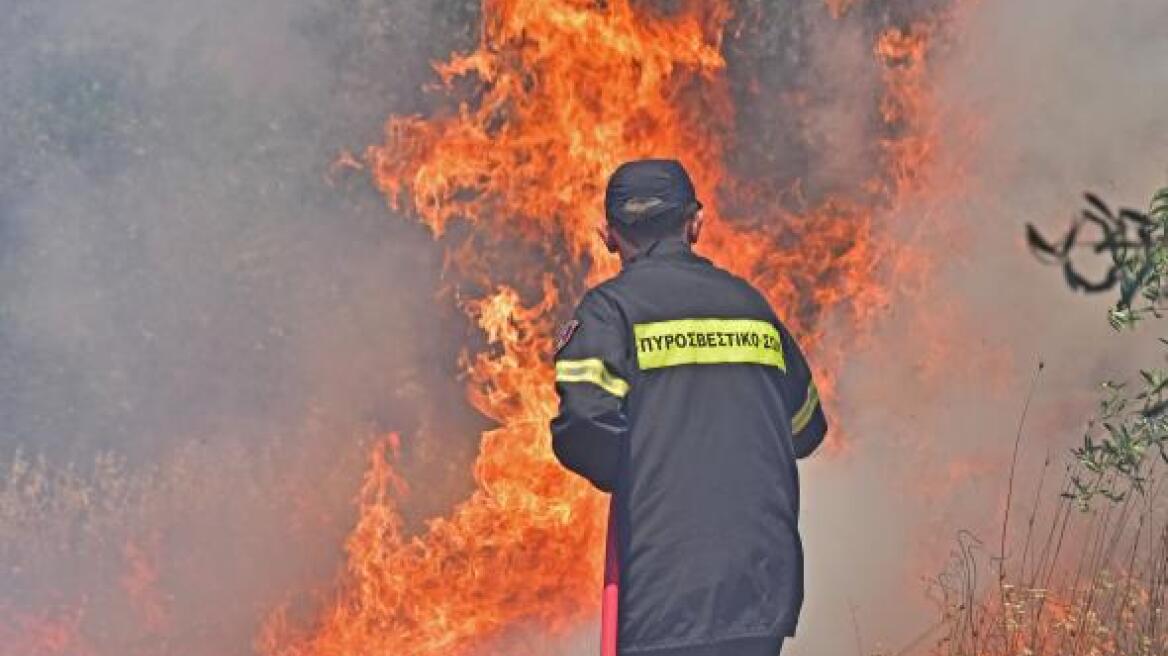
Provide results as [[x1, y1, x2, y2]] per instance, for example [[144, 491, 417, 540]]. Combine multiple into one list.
[[604, 160, 702, 225]]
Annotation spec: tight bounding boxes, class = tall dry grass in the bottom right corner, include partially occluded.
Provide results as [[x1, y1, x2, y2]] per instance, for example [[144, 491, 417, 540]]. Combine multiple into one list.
[[902, 459, 1168, 656]]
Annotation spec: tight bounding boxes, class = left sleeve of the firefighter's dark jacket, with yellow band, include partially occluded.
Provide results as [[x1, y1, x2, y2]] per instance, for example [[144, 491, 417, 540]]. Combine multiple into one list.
[[551, 291, 631, 491]]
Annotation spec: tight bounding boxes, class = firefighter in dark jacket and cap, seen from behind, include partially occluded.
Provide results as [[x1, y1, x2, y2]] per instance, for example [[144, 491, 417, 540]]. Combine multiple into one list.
[[551, 160, 827, 656]]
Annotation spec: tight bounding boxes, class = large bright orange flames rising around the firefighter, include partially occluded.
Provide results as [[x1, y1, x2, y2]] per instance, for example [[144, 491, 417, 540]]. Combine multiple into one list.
[[259, 0, 931, 656]]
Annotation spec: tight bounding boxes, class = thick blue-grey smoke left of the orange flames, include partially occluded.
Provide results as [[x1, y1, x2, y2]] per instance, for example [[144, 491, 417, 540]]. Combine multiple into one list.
[[0, 0, 482, 656]]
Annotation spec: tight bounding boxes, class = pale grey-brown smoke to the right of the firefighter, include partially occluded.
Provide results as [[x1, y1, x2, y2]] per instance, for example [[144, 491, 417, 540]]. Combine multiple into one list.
[[785, 0, 1168, 654]]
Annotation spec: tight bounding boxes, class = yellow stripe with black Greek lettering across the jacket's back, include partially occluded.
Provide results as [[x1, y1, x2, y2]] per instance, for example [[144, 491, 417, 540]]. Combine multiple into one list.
[[633, 319, 786, 371]]
